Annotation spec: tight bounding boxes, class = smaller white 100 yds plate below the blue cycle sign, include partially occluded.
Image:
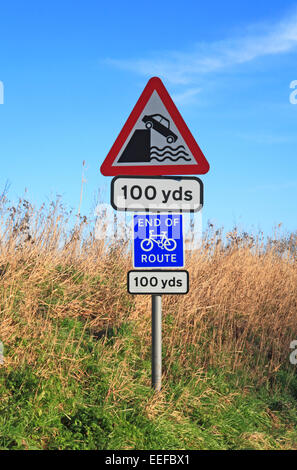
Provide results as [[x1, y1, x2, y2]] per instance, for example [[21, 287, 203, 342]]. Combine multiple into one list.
[[128, 270, 189, 295]]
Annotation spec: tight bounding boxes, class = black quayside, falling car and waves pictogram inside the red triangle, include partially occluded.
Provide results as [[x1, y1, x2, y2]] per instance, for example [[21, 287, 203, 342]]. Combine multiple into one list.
[[118, 114, 191, 163]]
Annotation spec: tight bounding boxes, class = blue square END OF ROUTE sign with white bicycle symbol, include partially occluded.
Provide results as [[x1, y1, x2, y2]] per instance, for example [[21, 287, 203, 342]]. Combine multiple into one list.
[[133, 214, 184, 269]]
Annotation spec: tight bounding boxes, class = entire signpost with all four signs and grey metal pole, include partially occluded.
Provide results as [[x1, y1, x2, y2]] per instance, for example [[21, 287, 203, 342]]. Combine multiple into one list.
[[100, 77, 209, 391]]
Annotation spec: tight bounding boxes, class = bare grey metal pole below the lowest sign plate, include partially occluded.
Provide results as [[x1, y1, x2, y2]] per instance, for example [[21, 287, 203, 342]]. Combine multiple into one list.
[[152, 295, 162, 392]]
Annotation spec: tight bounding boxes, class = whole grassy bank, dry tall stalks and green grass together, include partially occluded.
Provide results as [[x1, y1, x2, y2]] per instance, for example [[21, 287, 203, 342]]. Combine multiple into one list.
[[0, 197, 297, 449]]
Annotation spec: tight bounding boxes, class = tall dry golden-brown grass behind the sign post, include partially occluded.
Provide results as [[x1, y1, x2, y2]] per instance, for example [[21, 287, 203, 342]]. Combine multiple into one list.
[[0, 193, 297, 380]]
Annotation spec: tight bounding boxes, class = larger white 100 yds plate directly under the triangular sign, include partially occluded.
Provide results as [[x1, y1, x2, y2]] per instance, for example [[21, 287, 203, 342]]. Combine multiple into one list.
[[111, 176, 203, 212]]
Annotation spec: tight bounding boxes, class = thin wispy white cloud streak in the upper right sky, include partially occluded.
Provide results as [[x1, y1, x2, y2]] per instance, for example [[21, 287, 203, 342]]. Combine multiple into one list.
[[107, 10, 297, 85]]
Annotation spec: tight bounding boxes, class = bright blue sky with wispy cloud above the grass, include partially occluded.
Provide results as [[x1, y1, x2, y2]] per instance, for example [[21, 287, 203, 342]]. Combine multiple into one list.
[[0, 0, 297, 233]]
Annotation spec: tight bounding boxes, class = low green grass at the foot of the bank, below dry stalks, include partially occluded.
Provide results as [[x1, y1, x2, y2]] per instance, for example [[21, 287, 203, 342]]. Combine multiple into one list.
[[0, 312, 297, 450]]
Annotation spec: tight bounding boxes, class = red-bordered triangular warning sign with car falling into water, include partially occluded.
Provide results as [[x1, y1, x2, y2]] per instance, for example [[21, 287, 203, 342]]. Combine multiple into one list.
[[101, 77, 209, 176]]
